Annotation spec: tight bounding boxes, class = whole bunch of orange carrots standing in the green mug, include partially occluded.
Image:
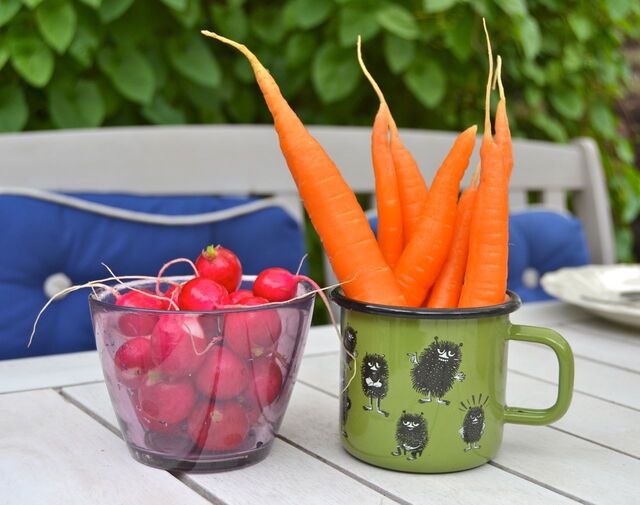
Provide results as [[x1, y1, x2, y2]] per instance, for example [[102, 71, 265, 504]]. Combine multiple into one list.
[[202, 19, 513, 308]]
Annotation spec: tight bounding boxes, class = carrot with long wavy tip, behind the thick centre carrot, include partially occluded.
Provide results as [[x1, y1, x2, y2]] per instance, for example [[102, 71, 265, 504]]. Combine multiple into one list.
[[357, 36, 428, 245]]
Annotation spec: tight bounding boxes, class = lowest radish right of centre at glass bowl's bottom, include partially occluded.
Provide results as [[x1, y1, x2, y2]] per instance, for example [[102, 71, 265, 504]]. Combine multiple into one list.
[[187, 402, 249, 451]]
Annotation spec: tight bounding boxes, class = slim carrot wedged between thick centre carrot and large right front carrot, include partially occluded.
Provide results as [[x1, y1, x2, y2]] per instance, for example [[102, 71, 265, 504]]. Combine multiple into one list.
[[426, 165, 480, 309]]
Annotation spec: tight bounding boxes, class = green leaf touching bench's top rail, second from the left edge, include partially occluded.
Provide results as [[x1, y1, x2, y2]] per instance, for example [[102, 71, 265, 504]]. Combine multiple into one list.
[[49, 79, 106, 128]]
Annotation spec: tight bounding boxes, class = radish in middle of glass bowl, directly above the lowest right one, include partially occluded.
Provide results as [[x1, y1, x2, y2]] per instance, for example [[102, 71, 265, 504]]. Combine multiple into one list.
[[196, 347, 249, 400]]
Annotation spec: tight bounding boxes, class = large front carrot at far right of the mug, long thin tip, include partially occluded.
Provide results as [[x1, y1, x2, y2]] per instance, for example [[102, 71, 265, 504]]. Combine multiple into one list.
[[459, 20, 509, 307]]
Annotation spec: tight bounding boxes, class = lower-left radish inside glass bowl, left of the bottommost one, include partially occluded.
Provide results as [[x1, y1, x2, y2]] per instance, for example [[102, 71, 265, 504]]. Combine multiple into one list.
[[138, 373, 196, 426]]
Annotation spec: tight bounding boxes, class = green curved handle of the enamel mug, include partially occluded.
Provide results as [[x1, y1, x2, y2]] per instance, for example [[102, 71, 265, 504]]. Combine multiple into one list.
[[504, 324, 573, 425]]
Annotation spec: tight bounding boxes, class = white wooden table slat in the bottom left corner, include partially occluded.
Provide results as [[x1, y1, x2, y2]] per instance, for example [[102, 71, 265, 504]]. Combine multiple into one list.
[[0, 390, 209, 505]]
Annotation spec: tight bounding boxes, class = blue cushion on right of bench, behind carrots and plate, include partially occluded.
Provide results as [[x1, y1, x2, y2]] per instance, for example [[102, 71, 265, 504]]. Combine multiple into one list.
[[369, 210, 589, 302]]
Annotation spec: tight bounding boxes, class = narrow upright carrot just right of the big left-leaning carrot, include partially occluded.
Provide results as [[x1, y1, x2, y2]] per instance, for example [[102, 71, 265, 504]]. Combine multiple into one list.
[[371, 103, 404, 268]]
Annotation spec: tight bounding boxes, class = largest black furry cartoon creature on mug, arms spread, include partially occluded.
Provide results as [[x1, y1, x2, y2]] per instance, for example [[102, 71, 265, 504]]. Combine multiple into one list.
[[408, 337, 464, 405]]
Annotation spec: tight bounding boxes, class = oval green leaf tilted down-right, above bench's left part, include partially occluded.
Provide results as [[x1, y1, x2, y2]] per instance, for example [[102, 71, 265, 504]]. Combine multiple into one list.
[[98, 47, 156, 104]]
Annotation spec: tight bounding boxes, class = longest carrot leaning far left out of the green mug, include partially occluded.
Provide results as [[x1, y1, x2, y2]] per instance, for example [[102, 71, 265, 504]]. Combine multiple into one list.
[[202, 30, 405, 305]]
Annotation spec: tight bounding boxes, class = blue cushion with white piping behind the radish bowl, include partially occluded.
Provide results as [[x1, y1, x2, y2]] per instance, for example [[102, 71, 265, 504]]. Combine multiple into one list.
[[0, 194, 305, 359]]
